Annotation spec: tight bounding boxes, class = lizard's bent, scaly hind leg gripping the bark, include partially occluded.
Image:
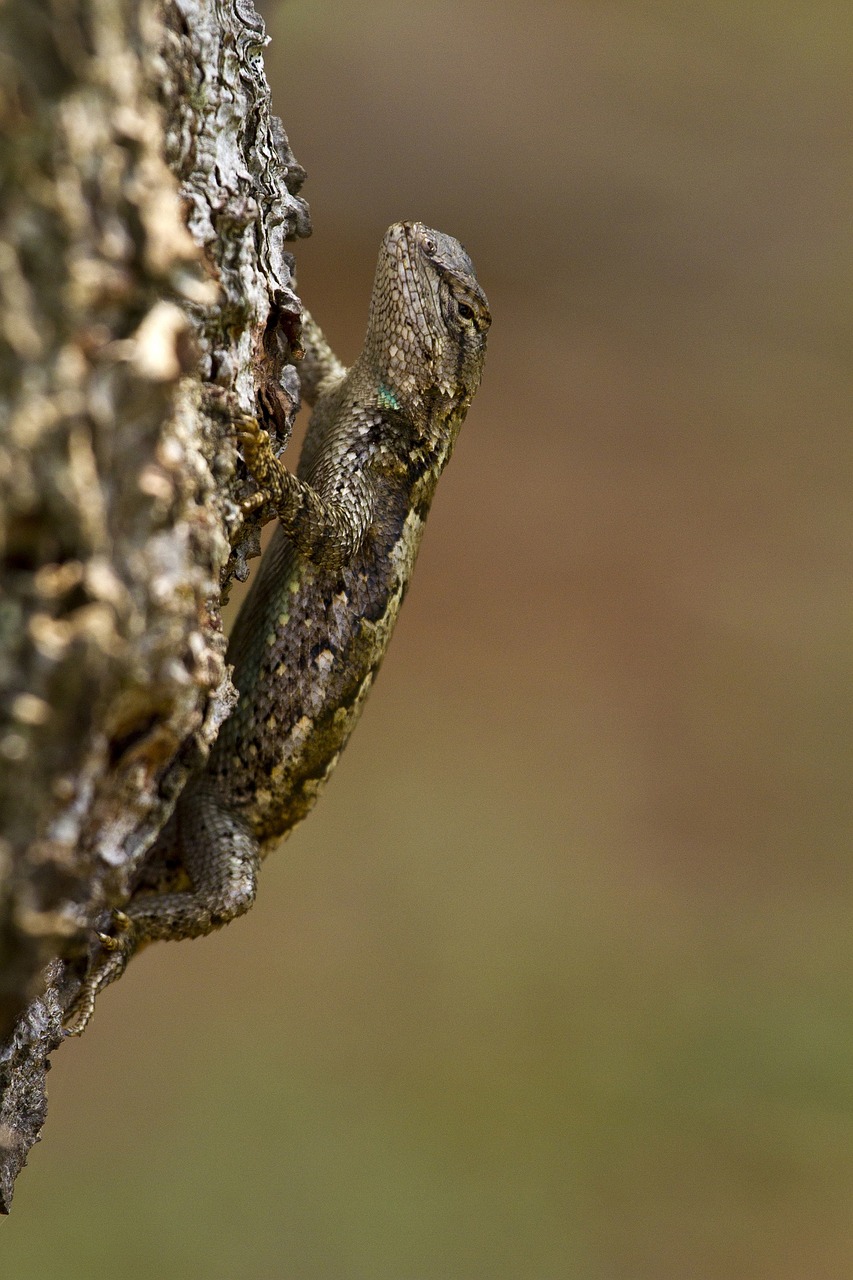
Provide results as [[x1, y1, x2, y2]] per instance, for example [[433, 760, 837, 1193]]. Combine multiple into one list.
[[64, 778, 260, 1036]]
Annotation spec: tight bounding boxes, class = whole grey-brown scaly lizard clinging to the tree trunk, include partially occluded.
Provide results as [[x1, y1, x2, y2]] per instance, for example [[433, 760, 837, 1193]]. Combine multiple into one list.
[[65, 221, 491, 1036]]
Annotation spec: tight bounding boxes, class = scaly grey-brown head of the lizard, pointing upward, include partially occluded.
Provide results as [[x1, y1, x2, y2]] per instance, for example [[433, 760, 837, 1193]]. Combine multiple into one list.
[[365, 223, 492, 437]]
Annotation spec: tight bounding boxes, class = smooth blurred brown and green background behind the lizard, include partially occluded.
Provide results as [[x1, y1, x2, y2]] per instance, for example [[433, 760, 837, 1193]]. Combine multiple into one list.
[[0, 0, 853, 1280]]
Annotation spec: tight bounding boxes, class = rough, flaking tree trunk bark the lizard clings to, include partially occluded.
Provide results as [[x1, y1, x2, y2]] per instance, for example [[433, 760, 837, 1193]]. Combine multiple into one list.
[[0, 0, 310, 1212]]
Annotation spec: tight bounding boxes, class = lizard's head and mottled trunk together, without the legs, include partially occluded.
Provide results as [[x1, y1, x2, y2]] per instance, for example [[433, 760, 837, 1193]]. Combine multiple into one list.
[[207, 223, 489, 845]]
